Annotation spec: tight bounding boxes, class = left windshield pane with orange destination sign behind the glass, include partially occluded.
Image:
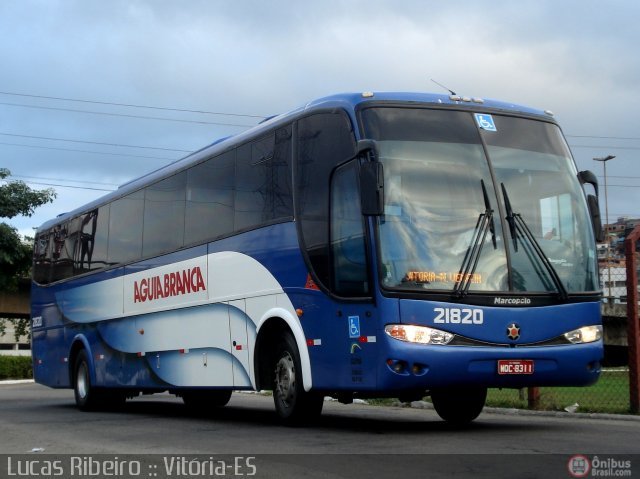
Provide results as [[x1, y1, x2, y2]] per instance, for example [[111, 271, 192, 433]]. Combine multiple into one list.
[[363, 108, 508, 291]]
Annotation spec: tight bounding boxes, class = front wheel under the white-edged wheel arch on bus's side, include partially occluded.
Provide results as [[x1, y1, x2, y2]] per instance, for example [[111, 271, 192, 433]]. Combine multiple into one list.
[[273, 332, 324, 426]]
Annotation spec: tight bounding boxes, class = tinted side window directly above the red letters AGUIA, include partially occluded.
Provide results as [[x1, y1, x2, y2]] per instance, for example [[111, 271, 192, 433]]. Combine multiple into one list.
[[142, 172, 187, 256]]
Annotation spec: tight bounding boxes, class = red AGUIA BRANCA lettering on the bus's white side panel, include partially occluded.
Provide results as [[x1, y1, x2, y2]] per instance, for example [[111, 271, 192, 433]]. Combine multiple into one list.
[[133, 266, 207, 303]]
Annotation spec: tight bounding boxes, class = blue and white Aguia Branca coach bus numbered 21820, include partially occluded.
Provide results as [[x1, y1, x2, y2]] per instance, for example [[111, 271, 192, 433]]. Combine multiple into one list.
[[32, 92, 603, 423]]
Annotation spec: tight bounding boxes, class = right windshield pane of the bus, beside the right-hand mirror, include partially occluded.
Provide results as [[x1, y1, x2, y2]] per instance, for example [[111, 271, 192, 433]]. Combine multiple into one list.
[[482, 115, 599, 292]]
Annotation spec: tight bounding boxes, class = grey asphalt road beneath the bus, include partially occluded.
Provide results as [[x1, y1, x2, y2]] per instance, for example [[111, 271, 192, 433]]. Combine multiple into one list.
[[0, 384, 640, 478]]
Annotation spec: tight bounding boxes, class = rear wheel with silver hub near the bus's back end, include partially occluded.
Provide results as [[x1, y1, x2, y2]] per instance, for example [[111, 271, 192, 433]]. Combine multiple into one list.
[[73, 349, 126, 411]]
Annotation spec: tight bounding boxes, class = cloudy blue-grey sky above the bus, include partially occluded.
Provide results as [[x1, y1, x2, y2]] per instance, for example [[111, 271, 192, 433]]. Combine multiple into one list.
[[0, 0, 640, 240]]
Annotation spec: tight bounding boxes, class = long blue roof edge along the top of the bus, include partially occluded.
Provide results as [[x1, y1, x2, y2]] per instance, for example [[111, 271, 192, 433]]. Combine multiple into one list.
[[38, 92, 552, 232]]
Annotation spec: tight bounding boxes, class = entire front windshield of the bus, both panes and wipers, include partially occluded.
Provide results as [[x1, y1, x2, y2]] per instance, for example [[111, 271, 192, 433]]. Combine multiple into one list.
[[362, 107, 598, 294]]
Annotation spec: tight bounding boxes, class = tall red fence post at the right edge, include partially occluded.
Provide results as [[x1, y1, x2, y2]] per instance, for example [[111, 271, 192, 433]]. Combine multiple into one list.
[[624, 226, 640, 413]]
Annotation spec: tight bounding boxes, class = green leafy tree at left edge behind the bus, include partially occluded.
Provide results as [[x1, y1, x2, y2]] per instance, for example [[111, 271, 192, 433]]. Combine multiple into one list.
[[0, 168, 56, 290]]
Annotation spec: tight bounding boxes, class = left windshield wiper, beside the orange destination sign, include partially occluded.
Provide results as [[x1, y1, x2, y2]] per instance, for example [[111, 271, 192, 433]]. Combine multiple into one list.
[[453, 180, 497, 298]]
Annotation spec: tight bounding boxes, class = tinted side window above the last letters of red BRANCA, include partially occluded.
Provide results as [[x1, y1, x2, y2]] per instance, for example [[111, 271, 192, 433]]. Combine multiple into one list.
[[185, 151, 236, 244]]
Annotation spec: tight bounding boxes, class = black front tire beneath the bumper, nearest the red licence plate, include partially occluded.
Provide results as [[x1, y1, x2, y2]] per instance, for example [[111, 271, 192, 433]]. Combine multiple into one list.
[[431, 388, 487, 426]]
